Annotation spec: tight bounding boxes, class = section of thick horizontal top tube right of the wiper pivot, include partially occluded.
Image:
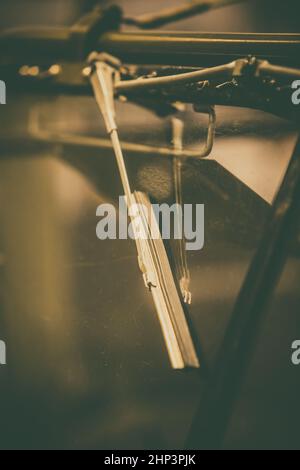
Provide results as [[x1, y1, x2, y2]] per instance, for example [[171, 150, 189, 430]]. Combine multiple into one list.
[[98, 32, 300, 67]]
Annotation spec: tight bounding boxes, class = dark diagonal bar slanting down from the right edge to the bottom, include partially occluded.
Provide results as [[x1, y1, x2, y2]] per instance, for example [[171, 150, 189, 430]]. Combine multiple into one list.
[[188, 135, 300, 449]]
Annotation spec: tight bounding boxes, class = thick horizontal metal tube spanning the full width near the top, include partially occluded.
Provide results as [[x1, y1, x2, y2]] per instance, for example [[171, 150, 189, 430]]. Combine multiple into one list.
[[0, 29, 300, 67]]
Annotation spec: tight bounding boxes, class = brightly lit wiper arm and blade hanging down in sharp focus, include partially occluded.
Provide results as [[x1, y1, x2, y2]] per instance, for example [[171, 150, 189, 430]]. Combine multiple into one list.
[[90, 54, 200, 369]]
